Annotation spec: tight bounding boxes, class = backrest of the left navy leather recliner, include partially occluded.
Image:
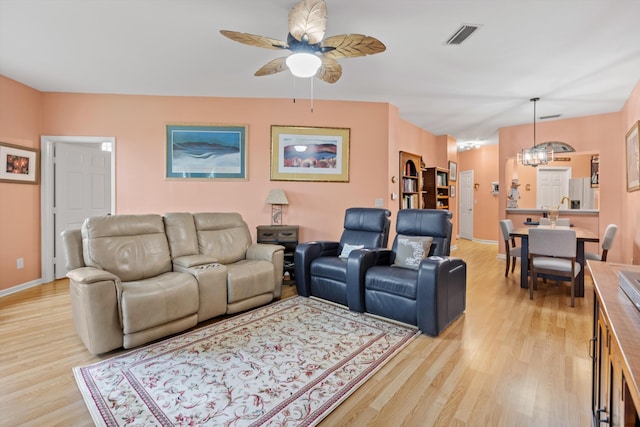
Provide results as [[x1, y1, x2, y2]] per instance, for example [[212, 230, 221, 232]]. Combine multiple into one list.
[[338, 208, 391, 253]]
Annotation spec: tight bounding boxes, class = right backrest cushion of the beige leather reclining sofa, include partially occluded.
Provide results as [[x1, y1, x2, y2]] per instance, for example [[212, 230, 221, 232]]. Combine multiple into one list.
[[193, 212, 252, 264]]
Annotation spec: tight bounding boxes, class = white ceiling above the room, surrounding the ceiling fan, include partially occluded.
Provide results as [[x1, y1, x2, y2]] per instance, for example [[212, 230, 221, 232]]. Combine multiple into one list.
[[0, 0, 640, 150]]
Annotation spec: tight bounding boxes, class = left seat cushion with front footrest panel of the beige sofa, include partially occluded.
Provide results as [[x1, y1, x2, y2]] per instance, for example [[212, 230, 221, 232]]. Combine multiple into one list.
[[120, 272, 200, 334]]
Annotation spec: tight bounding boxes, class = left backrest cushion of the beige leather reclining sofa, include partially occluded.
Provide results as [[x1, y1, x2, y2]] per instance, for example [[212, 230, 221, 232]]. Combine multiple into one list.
[[82, 214, 171, 282]]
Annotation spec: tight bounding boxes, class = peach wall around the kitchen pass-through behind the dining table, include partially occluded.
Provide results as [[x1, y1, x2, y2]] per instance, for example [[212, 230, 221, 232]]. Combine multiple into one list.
[[499, 113, 624, 262]]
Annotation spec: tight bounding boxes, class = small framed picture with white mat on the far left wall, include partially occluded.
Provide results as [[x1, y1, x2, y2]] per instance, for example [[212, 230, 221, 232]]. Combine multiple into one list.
[[0, 142, 40, 184]]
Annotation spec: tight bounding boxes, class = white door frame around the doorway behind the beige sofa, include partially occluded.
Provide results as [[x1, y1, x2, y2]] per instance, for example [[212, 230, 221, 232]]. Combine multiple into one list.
[[40, 136, 116, 283]]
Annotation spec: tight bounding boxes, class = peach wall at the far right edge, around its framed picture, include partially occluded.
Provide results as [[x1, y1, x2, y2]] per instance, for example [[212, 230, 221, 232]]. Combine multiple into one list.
[[618, 82, 640, 264]]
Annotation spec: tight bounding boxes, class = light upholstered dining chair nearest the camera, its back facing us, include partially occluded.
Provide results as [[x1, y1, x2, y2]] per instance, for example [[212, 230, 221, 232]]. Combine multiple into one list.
[[529, 228, 582, 307]]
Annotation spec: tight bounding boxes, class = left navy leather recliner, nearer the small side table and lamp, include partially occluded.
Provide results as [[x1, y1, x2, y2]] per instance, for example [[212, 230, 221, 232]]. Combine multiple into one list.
[[294, 208, 391, 312]]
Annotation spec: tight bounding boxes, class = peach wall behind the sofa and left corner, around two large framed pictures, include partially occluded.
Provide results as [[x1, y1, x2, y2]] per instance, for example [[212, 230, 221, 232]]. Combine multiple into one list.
[[0, 78, 446, 290]]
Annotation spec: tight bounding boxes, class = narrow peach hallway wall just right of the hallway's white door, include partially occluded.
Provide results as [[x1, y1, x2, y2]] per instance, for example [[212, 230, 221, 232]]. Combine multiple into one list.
[[458, 144, 502, 242]]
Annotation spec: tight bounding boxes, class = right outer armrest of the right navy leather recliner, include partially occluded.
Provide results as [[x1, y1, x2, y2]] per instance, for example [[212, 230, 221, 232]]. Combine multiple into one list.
[[416, 256, 467, 336]]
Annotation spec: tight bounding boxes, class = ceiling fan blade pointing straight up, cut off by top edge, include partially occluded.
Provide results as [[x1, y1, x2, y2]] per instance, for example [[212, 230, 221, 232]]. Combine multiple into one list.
[[289, 0, 327, 44]]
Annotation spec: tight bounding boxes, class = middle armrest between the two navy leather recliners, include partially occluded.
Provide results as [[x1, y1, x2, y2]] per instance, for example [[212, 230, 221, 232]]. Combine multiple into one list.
[[347, 249, 384, 313]]
